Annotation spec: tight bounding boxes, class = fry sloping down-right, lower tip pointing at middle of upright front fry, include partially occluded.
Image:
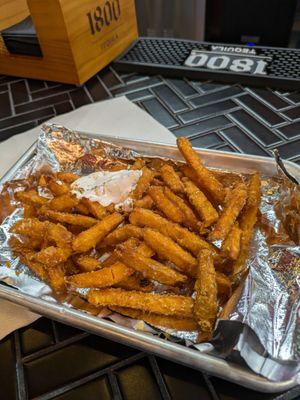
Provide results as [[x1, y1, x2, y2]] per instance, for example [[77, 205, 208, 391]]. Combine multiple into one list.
[[117, 247, 187, 286]]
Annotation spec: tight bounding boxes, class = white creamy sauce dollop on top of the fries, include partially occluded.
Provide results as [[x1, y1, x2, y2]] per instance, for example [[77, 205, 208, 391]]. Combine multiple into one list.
[[71, 170, 142, 211]]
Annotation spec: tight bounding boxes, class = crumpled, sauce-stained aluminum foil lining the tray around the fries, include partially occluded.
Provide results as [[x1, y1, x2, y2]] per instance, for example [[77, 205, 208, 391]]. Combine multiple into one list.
[[0, 125, 300, 381]]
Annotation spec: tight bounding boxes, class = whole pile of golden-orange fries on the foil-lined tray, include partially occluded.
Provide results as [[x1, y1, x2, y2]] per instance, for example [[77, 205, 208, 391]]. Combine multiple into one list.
[[10, 138, 260, 341]]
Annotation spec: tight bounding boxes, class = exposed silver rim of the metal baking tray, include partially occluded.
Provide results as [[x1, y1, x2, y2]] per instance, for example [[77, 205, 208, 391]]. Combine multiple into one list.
[[0, 132, 300, 393]]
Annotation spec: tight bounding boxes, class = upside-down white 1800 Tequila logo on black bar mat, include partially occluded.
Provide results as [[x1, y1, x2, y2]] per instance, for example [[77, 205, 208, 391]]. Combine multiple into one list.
[[184, 46, 272, 75]]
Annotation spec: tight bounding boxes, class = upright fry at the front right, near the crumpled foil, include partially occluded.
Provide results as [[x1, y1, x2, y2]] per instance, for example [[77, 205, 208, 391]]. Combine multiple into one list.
[[194, 249, 218, 332]]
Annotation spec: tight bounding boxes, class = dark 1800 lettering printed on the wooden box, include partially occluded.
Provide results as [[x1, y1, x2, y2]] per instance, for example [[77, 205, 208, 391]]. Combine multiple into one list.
[[87, 0, 121, 35]]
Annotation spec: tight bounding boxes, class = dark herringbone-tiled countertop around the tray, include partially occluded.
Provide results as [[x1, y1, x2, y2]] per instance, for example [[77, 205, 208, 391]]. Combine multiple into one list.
[[0, 68, 300, 400]]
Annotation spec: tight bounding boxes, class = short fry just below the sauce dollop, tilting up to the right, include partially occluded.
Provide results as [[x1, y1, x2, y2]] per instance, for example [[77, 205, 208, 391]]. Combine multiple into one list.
[[73, 213, 124, 252]]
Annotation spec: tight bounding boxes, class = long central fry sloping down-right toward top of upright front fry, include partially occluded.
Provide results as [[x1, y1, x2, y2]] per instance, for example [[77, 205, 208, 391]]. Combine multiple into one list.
[[129, 208, 212, 256]]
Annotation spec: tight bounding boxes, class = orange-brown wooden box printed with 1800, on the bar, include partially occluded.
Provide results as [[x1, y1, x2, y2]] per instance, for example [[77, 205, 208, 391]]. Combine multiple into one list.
[[0, 0, 137, 84]]
